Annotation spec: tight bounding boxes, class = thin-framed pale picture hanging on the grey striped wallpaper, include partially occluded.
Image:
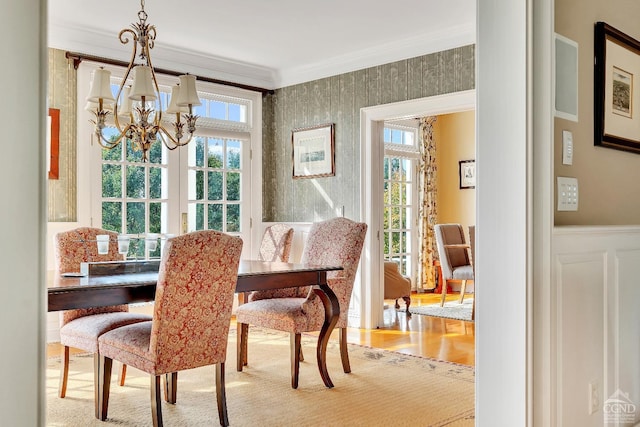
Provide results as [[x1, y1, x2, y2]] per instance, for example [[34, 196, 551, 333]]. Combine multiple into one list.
[[291, 123, 335, 179]]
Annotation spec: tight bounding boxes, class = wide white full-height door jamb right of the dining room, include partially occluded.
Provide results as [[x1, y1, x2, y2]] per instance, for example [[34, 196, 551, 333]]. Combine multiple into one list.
[[475, 0, 528, 427]]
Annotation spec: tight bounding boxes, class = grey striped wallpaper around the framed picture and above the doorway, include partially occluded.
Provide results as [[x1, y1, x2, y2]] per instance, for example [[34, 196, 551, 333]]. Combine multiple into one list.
[[262, 45, 475, 222]]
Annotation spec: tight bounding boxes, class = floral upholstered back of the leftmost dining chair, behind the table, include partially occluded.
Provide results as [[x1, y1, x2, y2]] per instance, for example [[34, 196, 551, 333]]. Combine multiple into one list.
[[53, 227, 129, 326]]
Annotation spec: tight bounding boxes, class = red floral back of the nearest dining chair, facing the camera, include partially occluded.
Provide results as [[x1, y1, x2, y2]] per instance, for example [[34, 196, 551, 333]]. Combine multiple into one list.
[[149, 230, 242, 372]]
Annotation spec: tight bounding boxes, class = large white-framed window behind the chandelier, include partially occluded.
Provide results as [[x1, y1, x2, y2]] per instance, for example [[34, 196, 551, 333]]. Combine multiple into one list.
[[78, 63, 262, 258]]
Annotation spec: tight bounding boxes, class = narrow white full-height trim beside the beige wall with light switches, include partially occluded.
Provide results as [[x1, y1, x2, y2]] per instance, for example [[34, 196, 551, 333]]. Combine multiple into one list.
[[527, 0, 558, 426]]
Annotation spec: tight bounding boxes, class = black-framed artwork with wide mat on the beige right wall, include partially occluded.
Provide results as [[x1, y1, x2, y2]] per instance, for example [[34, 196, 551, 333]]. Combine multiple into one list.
[[594, 22, 640, 153]]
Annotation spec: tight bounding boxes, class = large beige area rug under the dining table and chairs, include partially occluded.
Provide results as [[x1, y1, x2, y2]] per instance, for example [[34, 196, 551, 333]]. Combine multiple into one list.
[[46, 328, 475, 427]]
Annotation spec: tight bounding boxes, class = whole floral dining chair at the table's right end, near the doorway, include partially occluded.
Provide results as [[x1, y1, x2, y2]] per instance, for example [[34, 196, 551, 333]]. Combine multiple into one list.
[[236, 218, 367, 388]]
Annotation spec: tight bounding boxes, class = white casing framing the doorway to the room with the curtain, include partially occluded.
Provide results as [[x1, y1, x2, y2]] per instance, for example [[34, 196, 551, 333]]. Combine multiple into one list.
[[357, 90, 476, 329]]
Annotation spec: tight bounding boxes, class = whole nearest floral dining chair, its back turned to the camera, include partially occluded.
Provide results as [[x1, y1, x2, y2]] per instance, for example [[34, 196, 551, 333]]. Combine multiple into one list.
[[99, 230, 242, 426]]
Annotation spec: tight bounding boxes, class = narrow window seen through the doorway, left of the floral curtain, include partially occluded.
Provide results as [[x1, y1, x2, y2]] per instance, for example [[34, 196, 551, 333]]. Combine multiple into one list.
[[383, 123, 419, 283]]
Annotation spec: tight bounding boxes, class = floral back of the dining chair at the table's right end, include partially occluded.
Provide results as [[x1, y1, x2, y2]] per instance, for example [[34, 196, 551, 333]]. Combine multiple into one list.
[[302, 217, 367, 327]]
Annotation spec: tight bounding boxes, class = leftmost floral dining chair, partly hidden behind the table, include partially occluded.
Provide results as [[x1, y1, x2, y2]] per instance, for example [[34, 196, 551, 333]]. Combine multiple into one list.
[[54, 227, 151, 398]]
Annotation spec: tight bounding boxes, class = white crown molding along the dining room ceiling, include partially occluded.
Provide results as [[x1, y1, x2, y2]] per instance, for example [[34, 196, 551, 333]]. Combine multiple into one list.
[[49, 22, 475, 89]]
